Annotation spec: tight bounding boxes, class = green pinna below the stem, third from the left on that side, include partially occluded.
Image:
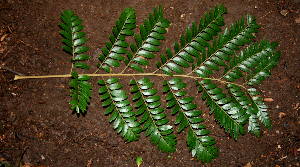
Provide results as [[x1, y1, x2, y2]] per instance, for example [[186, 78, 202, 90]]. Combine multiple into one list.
[[130, 78, 177, 152]]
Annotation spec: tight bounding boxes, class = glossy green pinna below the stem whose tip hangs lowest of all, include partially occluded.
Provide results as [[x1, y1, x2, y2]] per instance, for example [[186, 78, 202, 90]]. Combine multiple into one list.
[[164, 78, 218, 163]]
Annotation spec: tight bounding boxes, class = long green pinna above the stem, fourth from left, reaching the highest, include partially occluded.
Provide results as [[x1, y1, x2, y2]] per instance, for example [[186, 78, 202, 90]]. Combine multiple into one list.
[[157, 5, 227, 76]]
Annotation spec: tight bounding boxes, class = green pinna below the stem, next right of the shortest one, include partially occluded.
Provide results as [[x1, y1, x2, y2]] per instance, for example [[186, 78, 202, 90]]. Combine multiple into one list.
[[98, 78, 141, 142]]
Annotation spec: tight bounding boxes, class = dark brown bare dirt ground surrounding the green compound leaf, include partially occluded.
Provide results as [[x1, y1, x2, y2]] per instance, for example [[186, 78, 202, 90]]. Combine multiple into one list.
[[0, 0, 300, 167]]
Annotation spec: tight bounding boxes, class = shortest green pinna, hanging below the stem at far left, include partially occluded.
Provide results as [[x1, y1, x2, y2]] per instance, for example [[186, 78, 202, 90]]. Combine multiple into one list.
[[69, 70, 92, 113]]
